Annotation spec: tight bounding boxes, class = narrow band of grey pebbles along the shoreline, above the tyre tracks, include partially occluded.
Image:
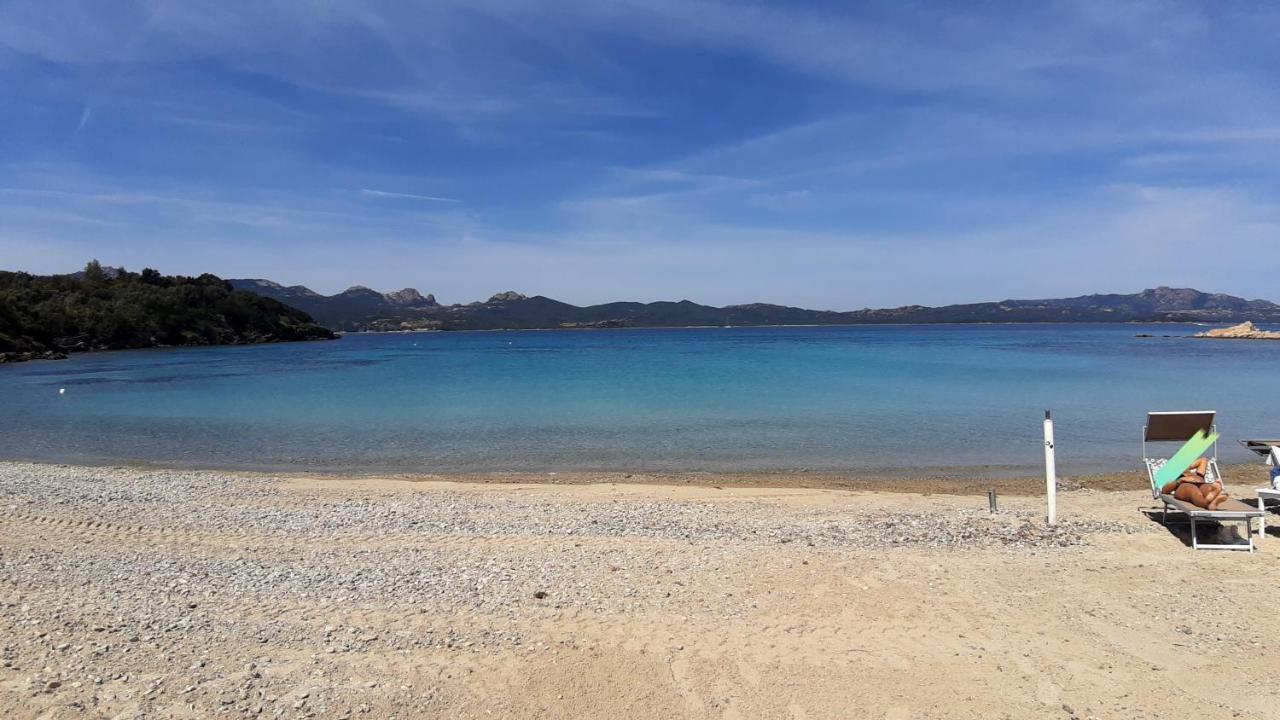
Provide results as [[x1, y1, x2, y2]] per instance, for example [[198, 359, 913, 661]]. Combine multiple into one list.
[[0, 464, 1148, 548]]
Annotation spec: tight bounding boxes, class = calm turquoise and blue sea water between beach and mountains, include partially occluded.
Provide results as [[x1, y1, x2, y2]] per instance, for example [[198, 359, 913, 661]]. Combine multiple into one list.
[[0, 325, 1280, 473]]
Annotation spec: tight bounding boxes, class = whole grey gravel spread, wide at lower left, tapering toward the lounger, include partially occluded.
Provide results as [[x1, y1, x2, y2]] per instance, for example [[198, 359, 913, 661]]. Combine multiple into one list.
[[0, 462, 1151, 717]]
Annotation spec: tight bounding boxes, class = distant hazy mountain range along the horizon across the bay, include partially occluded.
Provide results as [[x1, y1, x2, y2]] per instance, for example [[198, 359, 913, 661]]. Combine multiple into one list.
[[229, 279, 1280, 331]]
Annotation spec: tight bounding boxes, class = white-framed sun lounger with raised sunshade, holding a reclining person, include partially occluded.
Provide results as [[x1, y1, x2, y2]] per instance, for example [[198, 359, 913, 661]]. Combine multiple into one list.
[[1142, 410, 1263, 552]]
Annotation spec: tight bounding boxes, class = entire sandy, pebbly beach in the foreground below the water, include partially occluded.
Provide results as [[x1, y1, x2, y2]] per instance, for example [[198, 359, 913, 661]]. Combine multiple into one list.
[[0, 462, 1280, 719]]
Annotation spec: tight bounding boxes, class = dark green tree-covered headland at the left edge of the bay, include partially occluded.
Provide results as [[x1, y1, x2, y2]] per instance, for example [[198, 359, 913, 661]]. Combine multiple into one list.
[[0, 260, 337, 361]]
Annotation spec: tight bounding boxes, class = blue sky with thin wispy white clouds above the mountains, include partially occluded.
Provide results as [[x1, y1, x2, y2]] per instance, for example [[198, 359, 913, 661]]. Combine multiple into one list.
[[0, 0, 1280, 309]]
